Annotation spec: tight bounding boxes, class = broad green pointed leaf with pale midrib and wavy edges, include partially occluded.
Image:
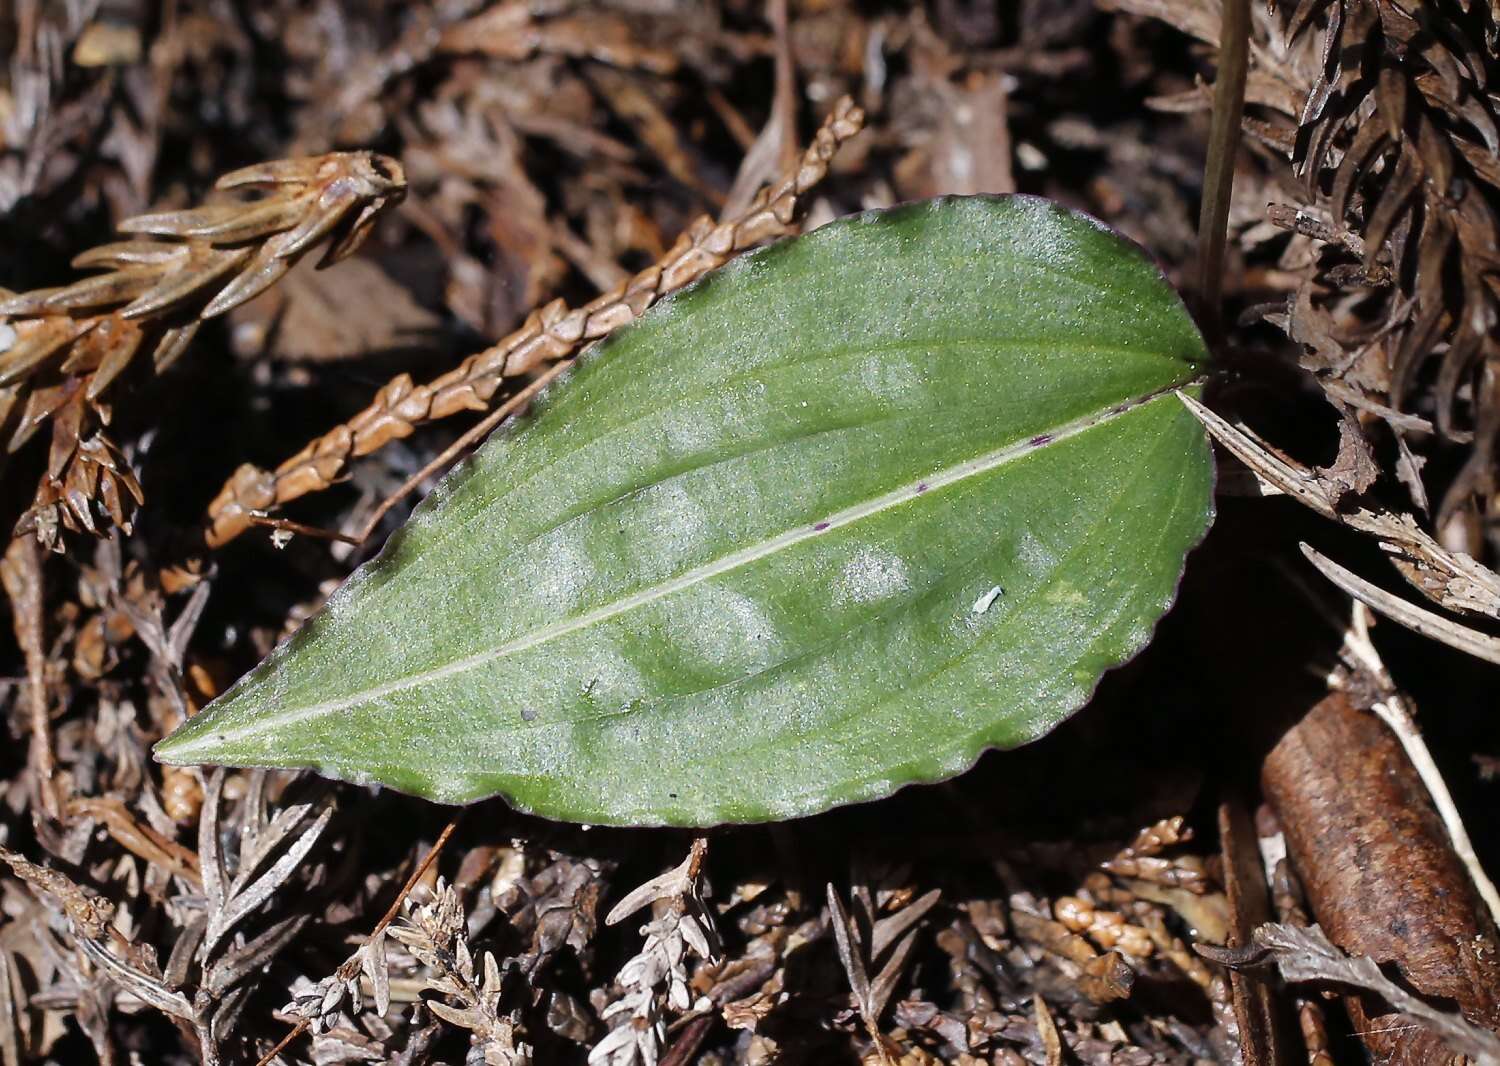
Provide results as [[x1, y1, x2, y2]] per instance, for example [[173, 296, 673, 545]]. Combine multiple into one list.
[[156, 196, 1212, 825]]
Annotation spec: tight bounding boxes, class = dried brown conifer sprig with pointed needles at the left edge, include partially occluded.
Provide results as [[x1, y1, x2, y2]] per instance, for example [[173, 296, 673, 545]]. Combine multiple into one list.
[[0, 151, 407, 547]]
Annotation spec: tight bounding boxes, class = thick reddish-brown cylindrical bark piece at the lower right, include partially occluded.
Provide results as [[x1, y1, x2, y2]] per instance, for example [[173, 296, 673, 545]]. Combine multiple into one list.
[[1262, 693, 1500, 1062]]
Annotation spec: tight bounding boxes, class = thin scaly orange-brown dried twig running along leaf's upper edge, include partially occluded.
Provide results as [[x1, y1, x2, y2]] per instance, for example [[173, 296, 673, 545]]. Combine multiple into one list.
[[207, 97, 864, 547]]
